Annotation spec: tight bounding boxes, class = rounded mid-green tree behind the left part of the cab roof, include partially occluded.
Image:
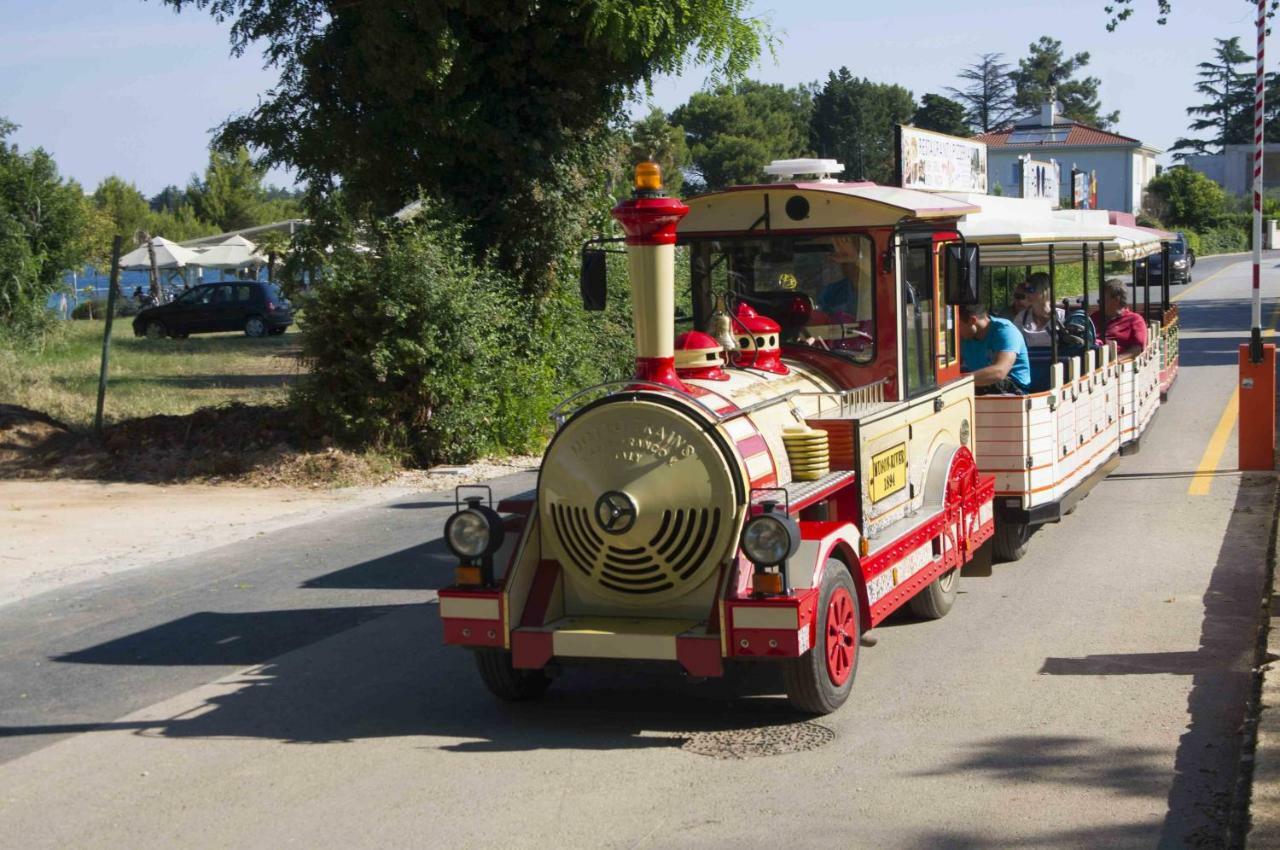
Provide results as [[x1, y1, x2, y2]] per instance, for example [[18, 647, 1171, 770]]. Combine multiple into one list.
[[671, 79, 813, 192]]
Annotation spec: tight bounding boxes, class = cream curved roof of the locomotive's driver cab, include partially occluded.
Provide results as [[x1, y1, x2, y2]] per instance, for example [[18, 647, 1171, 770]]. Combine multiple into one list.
[[678, 182, 979, 236]]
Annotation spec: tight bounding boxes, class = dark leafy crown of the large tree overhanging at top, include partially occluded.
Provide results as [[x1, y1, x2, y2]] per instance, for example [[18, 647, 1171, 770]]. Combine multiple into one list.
[[165, 0, 771, 296]]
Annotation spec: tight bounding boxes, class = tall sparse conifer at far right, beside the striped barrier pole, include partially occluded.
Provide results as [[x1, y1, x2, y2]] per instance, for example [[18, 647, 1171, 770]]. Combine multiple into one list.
[[1170, 37, 1253, 159]]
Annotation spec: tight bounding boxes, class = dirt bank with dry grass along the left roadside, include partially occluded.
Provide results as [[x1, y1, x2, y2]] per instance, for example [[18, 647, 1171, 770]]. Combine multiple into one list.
[[0, 405, 536, 488]]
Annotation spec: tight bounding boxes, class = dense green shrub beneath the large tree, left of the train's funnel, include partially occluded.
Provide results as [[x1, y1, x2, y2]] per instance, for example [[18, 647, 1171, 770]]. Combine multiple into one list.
[[286, 215, 631, 465]]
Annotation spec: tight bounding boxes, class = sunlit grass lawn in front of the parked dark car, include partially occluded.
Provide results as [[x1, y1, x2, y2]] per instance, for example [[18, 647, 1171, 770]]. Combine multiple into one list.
[[0, 319, 301, 428]]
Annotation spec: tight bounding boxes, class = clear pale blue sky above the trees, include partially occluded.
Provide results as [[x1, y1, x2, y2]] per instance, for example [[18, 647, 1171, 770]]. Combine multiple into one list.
[[0, 0, 1259, 193]]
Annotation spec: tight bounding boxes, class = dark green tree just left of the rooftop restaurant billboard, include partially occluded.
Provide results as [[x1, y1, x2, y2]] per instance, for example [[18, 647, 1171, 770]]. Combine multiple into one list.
[[809, 68, 915, 183]]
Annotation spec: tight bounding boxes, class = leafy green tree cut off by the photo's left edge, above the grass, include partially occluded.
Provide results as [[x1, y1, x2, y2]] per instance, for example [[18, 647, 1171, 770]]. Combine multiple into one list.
[[0, 118, 88, 338]]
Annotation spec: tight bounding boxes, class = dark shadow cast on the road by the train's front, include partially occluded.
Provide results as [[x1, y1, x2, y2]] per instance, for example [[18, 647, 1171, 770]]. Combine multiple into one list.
[[0, 596, 803, 753]]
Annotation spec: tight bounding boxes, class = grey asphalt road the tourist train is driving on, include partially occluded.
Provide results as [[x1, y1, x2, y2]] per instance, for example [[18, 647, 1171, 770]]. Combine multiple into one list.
[[0, 249, 1280, 847]]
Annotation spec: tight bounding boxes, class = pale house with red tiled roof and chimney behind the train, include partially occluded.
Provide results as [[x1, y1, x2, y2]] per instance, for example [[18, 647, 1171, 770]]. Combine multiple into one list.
[[977, 102, 1161, 213]]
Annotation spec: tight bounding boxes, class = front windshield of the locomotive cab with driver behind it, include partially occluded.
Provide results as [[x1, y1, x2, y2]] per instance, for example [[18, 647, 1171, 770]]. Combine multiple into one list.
[[690, 233, 876, 364]]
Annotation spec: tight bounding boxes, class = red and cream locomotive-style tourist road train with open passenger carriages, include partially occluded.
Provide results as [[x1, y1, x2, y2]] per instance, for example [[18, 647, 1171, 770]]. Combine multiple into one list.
[[439, 160, 1178, 714]]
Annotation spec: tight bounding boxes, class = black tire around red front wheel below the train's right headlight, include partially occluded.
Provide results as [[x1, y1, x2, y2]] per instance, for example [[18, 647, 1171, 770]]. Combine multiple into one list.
[[782, 558, 861, 714]]
